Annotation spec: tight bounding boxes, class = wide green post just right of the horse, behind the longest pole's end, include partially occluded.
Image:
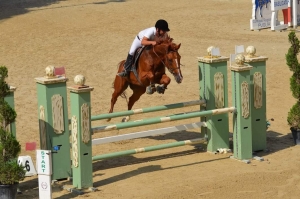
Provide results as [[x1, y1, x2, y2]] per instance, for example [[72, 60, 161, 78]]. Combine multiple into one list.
[[198, 49, 229, 152]]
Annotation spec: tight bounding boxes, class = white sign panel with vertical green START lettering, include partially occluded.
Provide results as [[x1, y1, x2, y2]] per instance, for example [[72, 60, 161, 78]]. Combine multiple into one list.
[[36, 150, 52, 175]]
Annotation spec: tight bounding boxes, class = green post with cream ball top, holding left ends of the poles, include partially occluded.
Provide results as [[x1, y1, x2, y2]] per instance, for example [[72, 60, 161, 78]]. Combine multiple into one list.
[[68, 75, 94, 189]]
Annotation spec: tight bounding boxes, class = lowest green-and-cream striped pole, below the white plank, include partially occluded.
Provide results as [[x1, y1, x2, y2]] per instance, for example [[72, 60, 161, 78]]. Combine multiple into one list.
[[92, 138, 207, 161]]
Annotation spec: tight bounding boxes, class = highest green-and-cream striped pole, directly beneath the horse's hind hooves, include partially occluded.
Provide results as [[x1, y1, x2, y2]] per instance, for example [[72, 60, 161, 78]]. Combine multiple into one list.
[[91, 100, 206, 121]]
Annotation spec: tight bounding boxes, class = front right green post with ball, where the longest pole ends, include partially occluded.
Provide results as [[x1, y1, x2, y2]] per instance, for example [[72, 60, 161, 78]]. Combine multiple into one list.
[[231, 54, 252, 160]]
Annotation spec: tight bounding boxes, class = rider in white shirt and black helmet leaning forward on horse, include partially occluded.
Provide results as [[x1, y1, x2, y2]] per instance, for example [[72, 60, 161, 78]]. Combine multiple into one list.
[[117, 19, 170, 77]]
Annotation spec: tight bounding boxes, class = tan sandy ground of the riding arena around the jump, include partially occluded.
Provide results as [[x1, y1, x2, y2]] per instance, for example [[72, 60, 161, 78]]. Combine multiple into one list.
[[0, 0, 300, 199]]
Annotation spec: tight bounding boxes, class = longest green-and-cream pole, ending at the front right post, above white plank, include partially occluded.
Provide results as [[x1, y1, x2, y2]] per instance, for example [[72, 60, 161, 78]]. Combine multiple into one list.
[[92, 107, 236, 133]]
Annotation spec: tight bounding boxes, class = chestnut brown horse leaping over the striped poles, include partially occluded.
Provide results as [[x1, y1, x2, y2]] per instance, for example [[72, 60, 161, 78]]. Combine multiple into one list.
[[107, 35, 183, 122]]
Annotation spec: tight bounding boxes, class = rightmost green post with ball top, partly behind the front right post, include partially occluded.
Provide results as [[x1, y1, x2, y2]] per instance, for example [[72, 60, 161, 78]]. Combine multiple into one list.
[[245, 46, 268, 151]]
